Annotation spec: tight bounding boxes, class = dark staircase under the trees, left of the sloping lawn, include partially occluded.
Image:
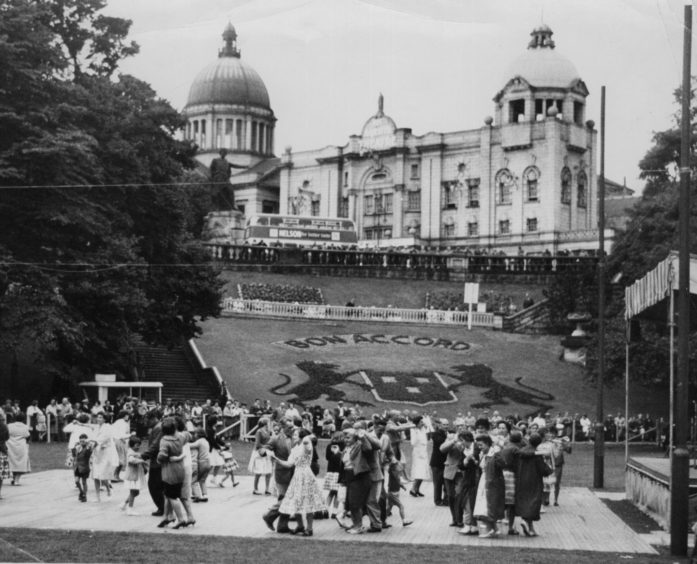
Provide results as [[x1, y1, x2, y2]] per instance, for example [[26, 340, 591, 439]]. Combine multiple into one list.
[[136, 342, 221, 402]]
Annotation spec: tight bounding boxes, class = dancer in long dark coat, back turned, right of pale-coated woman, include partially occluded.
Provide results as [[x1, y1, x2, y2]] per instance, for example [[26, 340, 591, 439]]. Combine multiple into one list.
[[515, 433, 552, 537]]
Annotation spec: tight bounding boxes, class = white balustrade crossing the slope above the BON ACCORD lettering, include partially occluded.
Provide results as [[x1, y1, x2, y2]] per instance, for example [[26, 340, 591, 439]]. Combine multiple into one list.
[[222, 298, 501, 328]]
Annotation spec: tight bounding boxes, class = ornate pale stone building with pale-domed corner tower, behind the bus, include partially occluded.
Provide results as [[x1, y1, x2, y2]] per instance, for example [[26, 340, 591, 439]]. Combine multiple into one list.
[[279, 25, 598, 254]]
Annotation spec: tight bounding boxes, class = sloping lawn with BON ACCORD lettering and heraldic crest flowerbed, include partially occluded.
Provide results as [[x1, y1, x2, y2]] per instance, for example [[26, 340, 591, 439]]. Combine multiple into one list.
[[197, 317, 668, 418]]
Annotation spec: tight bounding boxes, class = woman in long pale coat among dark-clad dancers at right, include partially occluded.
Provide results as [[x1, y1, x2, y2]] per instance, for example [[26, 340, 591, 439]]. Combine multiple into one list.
[[474, 435, 506, 539]]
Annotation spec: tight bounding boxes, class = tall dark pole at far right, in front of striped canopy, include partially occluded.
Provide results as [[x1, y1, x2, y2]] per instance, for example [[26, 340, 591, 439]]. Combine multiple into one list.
[[670, 5, 692, 556]]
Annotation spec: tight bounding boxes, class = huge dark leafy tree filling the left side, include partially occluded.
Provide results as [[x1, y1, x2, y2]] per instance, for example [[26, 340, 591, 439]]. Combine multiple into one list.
[[0, 0, 221, 396]]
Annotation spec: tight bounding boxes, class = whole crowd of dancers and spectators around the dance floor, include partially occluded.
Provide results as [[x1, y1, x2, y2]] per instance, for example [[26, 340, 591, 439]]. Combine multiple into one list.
[[0, 396, 664, 538]]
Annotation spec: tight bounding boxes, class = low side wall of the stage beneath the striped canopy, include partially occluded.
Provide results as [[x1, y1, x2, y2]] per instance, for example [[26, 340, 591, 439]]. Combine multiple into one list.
[[625, 457, 697, 530]]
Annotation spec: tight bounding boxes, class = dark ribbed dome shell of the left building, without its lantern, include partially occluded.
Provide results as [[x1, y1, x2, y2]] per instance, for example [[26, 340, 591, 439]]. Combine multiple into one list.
[[186, 57, 271, 109]]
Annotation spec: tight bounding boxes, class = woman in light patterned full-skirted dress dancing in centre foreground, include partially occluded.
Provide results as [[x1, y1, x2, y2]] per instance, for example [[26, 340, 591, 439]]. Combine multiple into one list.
[[269, 429, 327, 537]]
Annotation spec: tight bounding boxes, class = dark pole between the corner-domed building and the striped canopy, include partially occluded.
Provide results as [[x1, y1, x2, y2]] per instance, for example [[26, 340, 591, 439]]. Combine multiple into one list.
[[593, 86, 604, 488]]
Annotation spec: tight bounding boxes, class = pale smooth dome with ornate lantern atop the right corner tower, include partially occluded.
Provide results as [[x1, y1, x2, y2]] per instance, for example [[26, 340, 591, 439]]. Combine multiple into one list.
[[503, 25, 581, 88]]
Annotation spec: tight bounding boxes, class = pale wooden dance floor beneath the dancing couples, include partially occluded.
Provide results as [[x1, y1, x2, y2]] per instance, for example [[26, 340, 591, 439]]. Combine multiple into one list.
[[0, 470, 657, 554]]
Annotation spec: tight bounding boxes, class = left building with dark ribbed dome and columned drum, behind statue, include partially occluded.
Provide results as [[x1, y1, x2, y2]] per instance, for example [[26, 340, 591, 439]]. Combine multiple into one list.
[[183, 23, 280, 218]]
